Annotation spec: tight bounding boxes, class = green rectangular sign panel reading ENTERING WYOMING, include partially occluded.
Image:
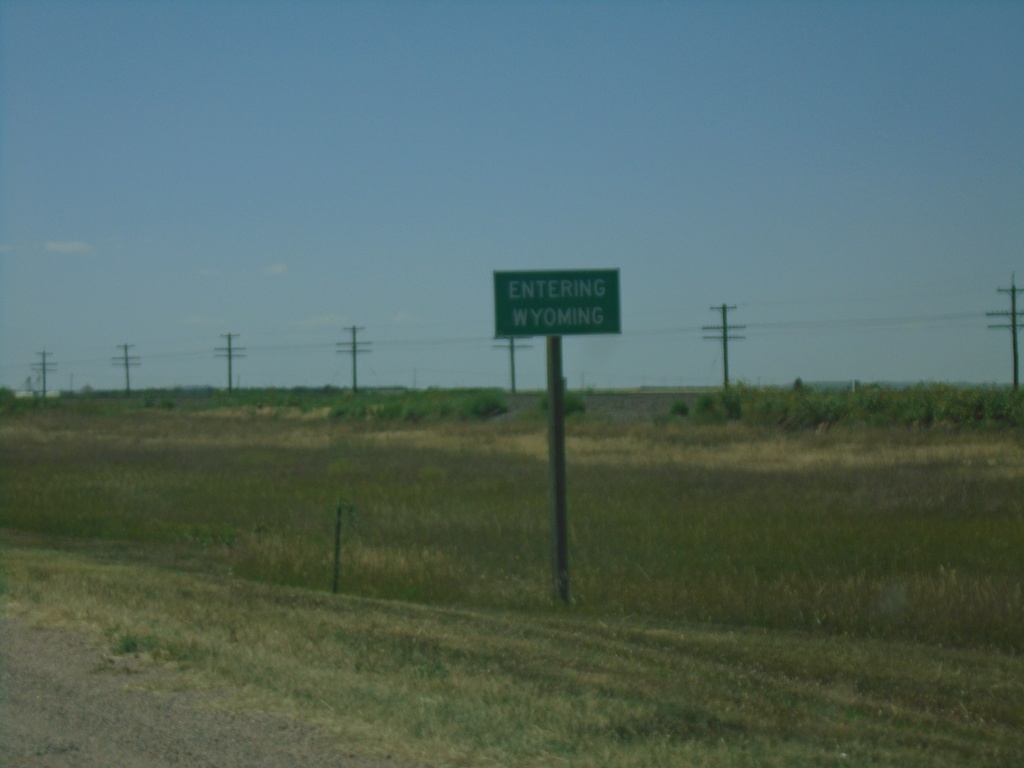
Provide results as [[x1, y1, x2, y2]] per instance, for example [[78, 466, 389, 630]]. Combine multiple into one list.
[[495, 269, 622, 337]]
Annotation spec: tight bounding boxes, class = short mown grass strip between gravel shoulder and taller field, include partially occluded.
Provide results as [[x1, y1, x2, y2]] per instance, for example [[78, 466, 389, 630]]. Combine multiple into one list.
[[6, 546, 1024, 768]]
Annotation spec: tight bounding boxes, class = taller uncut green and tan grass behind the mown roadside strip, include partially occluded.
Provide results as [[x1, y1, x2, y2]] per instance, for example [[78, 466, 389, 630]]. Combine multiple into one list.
[[0, 411, 1024, 652]]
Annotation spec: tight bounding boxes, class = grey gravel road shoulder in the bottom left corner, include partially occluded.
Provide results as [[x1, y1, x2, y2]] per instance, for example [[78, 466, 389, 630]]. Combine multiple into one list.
[[0, 617, 407, 768]]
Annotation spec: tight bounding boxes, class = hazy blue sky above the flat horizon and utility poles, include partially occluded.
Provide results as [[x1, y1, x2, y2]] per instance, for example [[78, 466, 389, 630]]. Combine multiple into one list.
[[0, 0, 1024, 389]]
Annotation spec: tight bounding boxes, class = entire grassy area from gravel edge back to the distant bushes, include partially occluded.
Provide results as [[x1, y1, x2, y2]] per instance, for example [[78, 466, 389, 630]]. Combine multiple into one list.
[[0, 409, 1024, 766]]
